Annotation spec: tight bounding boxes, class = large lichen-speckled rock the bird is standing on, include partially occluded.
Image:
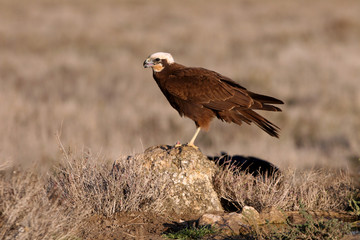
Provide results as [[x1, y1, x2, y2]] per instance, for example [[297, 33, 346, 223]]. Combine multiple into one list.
[[137, 145, 223, 218]]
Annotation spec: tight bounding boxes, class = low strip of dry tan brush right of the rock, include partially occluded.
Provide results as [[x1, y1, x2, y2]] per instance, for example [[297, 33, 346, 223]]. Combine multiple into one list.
[[214, 165, 356, 211]]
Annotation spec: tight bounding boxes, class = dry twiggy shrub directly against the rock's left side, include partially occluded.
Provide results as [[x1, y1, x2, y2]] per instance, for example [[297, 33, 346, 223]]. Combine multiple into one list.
[[47, 147, 172, 216]]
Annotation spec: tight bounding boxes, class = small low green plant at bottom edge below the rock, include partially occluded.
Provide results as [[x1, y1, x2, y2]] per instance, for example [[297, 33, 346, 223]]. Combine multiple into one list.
[[163, 227, 218, 240]]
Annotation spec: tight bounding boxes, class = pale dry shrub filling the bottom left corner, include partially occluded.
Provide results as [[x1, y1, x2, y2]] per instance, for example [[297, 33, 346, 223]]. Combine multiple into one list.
[[0, 169, 86, 239]]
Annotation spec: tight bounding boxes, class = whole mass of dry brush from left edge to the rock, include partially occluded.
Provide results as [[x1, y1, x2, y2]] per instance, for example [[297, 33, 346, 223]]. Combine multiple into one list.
[[0, 147, 172, 239]]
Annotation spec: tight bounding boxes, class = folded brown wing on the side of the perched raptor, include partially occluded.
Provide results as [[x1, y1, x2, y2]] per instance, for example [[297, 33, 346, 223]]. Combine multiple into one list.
[[165, 68, 254, 111]]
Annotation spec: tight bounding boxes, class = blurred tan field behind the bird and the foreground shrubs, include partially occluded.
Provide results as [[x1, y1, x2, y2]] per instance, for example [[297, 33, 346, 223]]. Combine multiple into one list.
[[0, 0, 360, 169]]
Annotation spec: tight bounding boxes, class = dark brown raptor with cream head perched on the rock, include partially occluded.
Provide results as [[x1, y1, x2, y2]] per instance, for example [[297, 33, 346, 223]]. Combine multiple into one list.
[[143, 52, 283, 146]]
